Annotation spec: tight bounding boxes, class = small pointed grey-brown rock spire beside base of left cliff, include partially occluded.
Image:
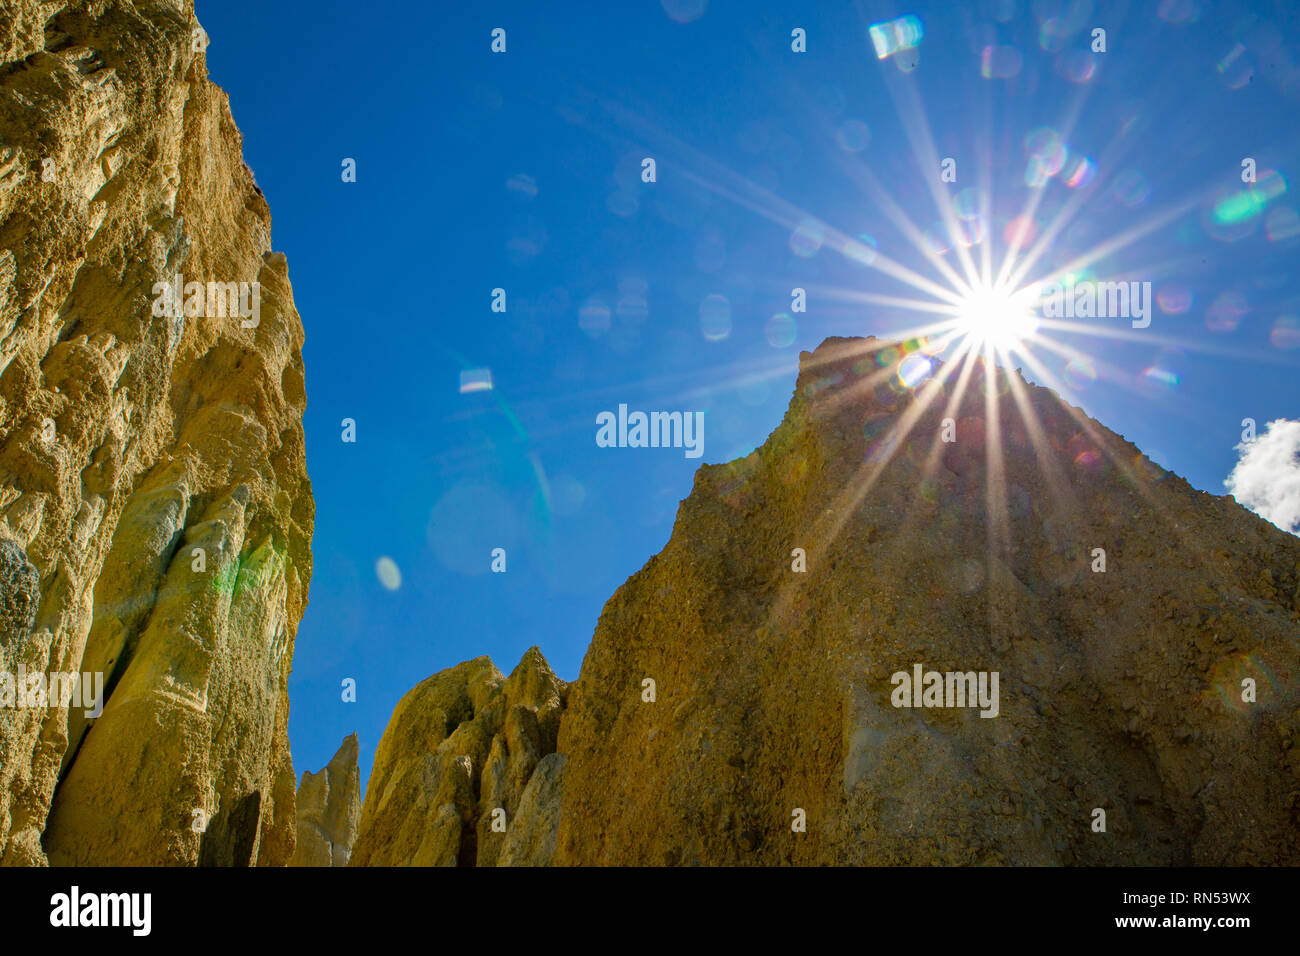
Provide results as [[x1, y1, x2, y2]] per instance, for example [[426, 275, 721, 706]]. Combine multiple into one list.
[[289, 734, 361, 866]]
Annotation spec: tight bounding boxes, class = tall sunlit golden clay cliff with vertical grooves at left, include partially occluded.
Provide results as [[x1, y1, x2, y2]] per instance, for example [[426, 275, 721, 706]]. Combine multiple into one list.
[[0, 0, 313, 865]]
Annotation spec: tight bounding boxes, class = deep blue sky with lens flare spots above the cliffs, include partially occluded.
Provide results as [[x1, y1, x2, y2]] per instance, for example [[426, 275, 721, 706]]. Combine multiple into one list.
[[198, 0, 1300, 774]]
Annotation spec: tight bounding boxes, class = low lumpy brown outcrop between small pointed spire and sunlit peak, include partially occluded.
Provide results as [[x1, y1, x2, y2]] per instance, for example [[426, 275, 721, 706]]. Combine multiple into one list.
[[351, 648, 568, 866]]
